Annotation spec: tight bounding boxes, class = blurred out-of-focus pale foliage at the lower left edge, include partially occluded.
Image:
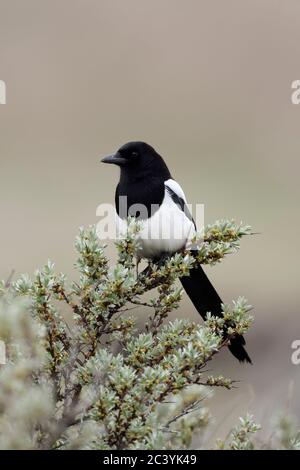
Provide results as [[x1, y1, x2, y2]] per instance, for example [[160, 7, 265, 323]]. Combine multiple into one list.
[[0, 299, 55, 449]]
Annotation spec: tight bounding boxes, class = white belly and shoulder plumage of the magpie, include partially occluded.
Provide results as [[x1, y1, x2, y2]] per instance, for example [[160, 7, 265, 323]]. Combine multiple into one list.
[[117, 179, 195, 259]]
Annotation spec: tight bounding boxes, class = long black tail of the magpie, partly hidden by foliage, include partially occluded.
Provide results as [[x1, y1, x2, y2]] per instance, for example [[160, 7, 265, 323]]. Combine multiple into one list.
[[180, 266, 252, 364]]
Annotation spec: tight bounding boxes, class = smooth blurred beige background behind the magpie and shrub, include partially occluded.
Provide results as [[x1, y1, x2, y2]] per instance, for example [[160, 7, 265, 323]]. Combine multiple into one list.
[[0, 0, 300, 437]]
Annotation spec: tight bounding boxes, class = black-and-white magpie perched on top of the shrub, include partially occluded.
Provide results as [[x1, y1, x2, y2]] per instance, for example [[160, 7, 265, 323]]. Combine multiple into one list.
[[102, 142, 251, 363]]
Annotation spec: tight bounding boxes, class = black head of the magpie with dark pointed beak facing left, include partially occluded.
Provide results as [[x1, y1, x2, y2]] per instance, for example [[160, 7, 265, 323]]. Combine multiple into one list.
[[101, 142, 169, 177]]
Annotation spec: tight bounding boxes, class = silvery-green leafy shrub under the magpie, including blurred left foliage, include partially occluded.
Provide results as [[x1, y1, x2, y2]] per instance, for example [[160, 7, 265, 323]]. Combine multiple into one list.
[[0, 220, 254, 449]]
